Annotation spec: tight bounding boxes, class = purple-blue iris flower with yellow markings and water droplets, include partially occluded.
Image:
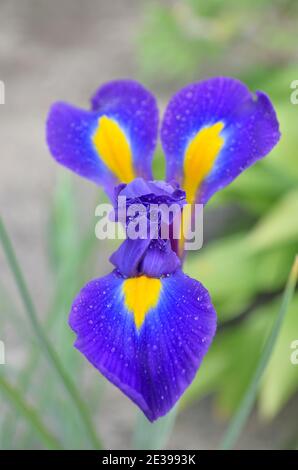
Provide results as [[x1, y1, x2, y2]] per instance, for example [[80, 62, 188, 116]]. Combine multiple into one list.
[[47, 77, 280, 421]]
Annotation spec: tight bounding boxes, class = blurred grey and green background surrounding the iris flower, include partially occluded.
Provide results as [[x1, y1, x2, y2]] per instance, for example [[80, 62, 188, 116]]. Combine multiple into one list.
[[0, 0, 298, 449]]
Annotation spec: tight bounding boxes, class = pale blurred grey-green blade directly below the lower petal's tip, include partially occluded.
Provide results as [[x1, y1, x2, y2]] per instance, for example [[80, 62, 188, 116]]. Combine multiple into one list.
[[133, 406, 178, 450]]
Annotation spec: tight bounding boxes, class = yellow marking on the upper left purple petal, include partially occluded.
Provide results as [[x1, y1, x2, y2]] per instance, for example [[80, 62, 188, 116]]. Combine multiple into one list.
[[92, 116, 135, 183]]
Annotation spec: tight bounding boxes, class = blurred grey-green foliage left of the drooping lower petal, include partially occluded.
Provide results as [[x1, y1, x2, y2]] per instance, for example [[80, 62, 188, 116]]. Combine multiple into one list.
[[0, 173, 102, 449]]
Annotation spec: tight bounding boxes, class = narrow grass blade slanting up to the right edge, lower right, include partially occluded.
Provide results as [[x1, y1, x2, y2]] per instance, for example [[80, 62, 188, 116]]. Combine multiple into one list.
[[220, 256, 298, 449]]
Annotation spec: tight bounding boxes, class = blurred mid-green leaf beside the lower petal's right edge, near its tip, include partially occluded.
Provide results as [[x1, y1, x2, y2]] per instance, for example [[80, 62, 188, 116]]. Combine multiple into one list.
[[181, 303, 273, 416]]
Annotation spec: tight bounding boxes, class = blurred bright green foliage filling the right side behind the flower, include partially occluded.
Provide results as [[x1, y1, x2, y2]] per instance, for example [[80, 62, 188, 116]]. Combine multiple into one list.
[[139, 0, 298, 419]]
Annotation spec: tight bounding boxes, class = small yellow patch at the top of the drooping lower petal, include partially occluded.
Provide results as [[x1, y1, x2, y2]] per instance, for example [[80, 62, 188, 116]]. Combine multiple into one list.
[[122, 275, 162, 328]]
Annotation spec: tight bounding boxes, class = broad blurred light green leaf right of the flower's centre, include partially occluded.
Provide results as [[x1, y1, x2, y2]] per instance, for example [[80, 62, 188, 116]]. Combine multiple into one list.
[[184, 209, 298, 322]]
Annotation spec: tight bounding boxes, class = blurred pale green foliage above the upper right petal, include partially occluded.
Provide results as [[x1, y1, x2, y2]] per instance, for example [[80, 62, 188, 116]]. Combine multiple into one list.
[[139, 0, 298, 86]]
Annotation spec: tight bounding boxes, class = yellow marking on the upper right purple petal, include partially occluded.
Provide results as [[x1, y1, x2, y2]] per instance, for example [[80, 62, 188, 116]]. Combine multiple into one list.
[[183, 122, 224, 204]]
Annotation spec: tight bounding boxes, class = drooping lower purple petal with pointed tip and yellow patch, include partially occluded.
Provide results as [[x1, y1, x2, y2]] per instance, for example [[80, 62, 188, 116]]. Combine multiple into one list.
[[70, 270, 216, 421]]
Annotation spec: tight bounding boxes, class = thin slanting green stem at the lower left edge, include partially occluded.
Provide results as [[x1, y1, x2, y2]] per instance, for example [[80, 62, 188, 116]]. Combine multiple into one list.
[[0, 218, 102, 449]]
